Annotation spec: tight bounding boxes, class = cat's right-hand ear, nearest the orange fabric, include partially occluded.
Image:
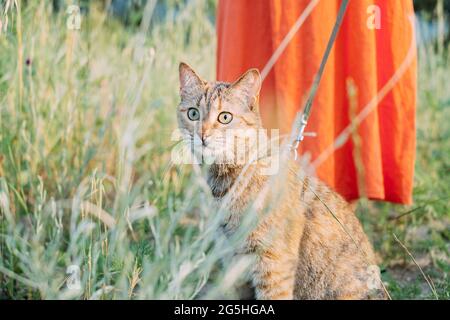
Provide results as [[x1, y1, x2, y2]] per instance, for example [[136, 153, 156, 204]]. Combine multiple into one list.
[[230, 69, 261, 110]]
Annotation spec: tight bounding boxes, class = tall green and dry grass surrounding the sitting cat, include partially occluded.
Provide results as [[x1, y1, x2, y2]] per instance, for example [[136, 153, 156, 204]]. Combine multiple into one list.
[[0, 1, 450, 299]]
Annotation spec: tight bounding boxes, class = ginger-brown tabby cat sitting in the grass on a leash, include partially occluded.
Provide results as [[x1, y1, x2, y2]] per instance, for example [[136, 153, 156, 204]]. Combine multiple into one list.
[[177, 63, 387, 299]]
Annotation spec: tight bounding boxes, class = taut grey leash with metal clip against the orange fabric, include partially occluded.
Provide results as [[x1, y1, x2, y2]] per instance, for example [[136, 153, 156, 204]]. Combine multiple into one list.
[[291, 0, 350, 160]]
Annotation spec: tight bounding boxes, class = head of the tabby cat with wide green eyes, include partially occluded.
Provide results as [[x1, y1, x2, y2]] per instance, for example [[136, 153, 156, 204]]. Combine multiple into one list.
[[177, 63, 261, 163]]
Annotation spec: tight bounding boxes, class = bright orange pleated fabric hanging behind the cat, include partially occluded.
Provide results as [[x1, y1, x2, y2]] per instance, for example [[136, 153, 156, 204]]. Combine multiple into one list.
[[217, 0, 416, 204]]
